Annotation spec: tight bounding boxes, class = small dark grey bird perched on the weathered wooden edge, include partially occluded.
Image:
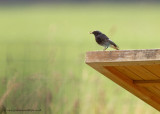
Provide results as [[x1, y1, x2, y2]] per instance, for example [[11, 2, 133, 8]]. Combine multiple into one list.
[[90, 31, 119, 51]]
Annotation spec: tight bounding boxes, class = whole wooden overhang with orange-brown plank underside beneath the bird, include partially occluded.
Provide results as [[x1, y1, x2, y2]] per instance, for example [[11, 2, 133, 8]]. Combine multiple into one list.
[[86, 49, 160, 111]]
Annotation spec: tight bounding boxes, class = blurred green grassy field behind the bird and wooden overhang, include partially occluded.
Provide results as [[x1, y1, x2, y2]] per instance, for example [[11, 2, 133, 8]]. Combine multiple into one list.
[[0, 3, 160, 114]]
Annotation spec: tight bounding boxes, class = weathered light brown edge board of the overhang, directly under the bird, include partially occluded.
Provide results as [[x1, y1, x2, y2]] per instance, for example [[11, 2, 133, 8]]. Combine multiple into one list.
[[86, 49, 160, 66]]
